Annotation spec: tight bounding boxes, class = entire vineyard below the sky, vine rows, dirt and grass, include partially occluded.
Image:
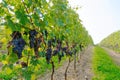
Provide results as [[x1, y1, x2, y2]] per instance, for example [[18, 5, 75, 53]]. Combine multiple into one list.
[[0, 0, 120, 80]]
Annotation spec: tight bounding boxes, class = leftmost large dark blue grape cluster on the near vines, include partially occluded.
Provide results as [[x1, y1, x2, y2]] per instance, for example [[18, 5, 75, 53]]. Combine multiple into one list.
[[11, 31, 26, 59]]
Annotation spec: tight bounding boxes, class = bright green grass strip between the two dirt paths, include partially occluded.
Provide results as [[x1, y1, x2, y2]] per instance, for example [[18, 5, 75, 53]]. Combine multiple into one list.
[[92, 46, 120, 80]]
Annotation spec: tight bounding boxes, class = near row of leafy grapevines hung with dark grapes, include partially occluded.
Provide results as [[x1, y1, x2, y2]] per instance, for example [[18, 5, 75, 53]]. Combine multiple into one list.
[[0, 0, 93, 80]]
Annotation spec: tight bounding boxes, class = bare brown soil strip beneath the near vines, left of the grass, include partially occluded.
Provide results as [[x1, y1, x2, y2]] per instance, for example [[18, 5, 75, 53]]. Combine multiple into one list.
[[37, 47, 93, 80]]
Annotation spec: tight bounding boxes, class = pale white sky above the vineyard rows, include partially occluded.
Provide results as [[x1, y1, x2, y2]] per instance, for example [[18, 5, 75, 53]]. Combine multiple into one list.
[[69, 0, 120, 43]]
